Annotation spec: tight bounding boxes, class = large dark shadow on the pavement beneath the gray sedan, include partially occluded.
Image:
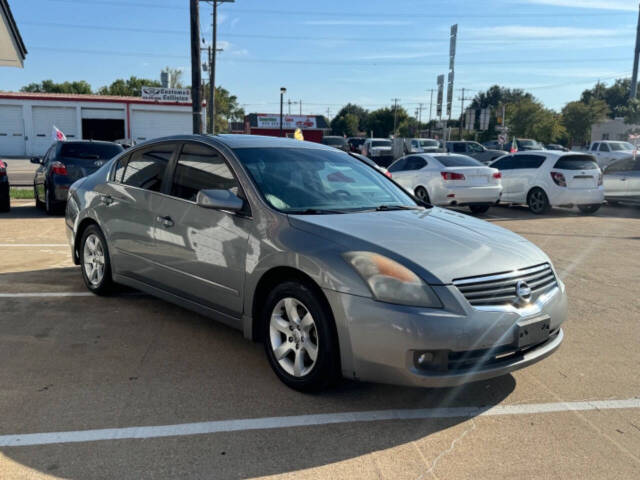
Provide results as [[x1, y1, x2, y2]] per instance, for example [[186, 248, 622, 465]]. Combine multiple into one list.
[[0, 267, 516, 479]]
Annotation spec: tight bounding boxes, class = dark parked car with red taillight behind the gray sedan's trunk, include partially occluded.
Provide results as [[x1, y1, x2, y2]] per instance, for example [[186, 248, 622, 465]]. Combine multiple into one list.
[[31, 140, 123, 215]]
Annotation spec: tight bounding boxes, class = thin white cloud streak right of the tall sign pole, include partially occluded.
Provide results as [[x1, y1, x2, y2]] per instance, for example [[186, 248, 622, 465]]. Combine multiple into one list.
[[465, 25, 629, 40]]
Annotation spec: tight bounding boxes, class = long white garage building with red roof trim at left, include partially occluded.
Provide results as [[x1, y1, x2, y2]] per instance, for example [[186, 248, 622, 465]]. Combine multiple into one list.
[[0, 92, 204, 157]]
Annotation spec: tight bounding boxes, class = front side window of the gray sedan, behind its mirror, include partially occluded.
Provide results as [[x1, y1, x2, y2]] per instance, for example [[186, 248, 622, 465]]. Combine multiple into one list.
[[171, 143, 238, 202]]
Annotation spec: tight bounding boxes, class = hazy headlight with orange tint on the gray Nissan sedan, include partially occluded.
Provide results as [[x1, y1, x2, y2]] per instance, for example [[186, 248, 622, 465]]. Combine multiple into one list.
[[344, 252, 442, 308]]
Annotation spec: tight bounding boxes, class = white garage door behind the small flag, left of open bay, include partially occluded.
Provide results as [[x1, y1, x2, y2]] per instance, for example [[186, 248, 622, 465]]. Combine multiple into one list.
[[31, 107, 79, 155]]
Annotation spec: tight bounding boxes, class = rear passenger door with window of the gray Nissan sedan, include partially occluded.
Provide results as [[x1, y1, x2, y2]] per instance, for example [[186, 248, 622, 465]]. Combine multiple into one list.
[[102, 142, 176, 286]]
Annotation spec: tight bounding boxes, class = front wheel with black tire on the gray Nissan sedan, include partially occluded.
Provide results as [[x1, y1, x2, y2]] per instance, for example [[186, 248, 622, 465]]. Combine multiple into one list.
[[262, 281, 339, 392]]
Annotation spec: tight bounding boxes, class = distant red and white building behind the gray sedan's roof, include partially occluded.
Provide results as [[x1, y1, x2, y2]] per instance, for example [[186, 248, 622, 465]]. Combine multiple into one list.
[[244, 113, 331, 143]]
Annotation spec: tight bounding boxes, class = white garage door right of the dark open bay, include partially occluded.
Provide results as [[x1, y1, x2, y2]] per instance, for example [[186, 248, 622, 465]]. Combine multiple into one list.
[[131, 110, 193, 142]]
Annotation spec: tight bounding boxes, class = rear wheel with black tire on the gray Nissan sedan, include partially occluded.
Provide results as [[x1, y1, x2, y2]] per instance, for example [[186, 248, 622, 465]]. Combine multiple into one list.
[[80, 225, 113, 295]]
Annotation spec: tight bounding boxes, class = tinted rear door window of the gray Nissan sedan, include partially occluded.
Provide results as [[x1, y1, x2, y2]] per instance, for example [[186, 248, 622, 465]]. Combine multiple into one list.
[[122, 143, 175, 192]]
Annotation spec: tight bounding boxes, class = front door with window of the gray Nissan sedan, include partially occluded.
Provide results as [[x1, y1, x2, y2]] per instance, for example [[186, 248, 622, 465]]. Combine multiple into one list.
[[153, 143, 252, 316]]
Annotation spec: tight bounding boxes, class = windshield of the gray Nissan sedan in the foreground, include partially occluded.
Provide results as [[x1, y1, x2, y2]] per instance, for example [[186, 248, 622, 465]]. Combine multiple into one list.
[[235, 148, 417, 213]]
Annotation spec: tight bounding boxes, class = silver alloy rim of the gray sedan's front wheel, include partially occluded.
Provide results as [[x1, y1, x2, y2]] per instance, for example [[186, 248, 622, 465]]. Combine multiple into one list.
[[269, 297, 318, 378]]
